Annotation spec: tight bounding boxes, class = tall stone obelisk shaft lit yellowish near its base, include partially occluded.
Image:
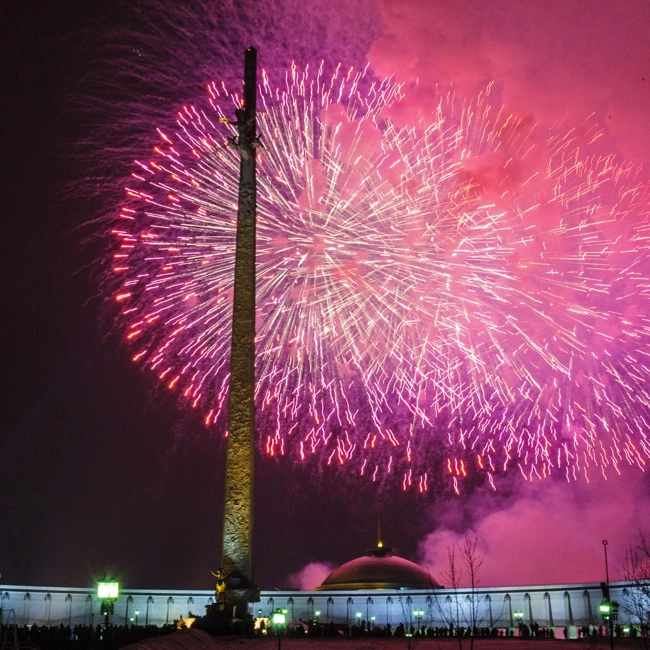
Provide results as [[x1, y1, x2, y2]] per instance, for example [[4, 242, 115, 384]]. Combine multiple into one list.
[[222, 47, 257, 589]]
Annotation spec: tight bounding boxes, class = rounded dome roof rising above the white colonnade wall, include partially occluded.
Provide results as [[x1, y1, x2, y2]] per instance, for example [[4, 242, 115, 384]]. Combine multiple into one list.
[[316, 546, 441, 591]]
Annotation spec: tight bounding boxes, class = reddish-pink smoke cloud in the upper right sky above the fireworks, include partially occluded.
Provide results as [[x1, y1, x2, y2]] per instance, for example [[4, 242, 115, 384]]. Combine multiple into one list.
[[368, 0, 650, 162]]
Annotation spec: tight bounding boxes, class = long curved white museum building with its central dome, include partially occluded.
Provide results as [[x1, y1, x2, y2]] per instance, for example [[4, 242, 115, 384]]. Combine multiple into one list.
[[0, 546, 636, 636]]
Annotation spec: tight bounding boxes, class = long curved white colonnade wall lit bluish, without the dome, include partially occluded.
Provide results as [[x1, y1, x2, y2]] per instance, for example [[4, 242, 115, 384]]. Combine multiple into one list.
[[0, 582, 636, 628]]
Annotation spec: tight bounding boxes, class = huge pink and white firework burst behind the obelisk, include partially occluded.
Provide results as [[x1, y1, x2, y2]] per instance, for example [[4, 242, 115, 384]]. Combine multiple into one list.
[[113, 66, 650, 491]]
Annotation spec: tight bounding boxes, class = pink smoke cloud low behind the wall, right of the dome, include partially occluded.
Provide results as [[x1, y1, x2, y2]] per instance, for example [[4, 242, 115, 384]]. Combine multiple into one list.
[[419, 474, 650, 586]]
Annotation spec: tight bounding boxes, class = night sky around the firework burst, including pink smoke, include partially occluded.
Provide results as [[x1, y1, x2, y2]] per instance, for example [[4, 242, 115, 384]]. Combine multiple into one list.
[[0, 0, 650, 589]]
